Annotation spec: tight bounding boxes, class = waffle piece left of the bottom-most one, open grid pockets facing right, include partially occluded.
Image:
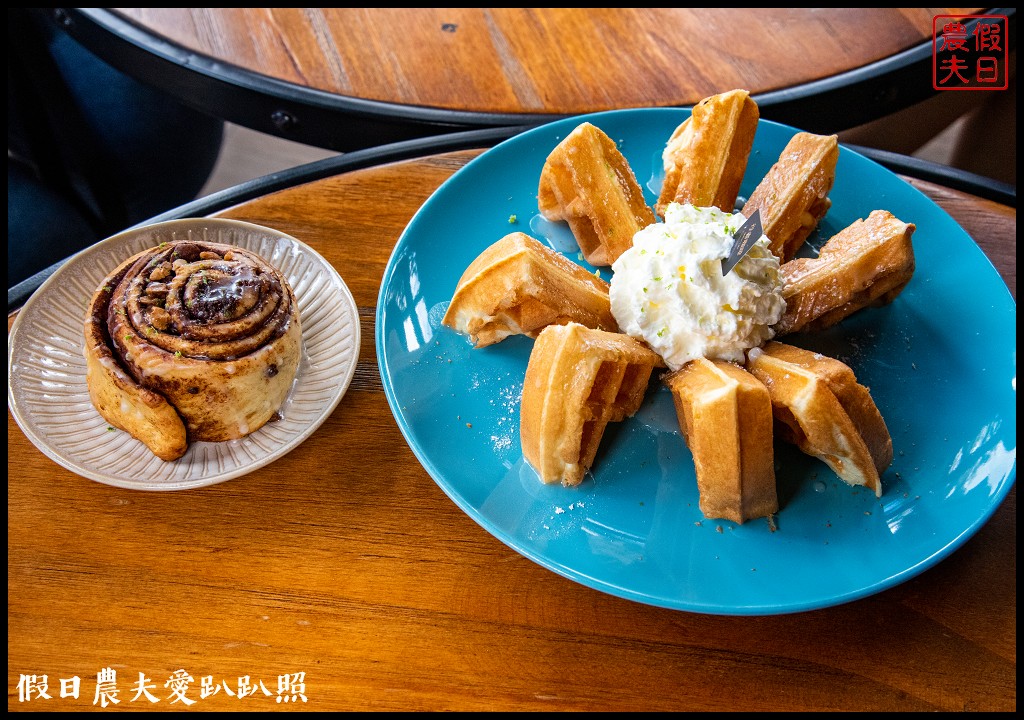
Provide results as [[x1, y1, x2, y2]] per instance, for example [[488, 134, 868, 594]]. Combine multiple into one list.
[[519, 323, 665, 485]]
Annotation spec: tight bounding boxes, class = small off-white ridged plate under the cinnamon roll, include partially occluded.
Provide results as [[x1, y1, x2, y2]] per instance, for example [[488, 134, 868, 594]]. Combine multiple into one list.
[[7, 218, 359, 491]]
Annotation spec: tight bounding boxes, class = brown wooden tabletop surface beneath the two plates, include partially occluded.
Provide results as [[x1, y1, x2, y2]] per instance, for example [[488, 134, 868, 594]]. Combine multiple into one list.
[[7, 143, 1017, 711]]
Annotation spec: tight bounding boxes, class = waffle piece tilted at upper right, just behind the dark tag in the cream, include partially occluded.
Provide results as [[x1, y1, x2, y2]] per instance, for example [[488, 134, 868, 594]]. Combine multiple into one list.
[[742, 132, 839, 262]]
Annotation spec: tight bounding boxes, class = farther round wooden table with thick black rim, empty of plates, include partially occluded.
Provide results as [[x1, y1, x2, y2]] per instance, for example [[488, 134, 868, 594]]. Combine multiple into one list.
[[39, 7, 995, 152]]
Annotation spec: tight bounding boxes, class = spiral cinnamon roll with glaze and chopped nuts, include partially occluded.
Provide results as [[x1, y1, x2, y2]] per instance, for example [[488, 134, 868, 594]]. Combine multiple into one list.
[[85, 242, 301, 460]]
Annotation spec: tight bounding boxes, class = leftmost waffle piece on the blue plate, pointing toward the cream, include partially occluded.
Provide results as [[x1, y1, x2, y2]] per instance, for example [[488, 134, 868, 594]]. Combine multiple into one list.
[[442, 232, 618, 347]]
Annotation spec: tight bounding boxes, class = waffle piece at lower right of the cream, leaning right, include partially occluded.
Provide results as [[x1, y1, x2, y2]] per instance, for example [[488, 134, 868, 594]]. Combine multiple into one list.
[[746, 341, 893, 497]]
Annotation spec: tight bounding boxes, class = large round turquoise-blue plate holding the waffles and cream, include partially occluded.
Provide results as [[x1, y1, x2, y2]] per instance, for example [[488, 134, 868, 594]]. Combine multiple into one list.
[[376, 109, 1017, 616]]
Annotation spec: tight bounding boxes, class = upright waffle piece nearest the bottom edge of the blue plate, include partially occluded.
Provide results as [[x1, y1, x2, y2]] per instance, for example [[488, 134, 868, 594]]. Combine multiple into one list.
[[664, 357, 778, 523]]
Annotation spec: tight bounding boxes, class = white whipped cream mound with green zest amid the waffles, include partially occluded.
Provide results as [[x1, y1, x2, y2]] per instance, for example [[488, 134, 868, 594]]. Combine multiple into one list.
[[610, 203, 785, 370]]
